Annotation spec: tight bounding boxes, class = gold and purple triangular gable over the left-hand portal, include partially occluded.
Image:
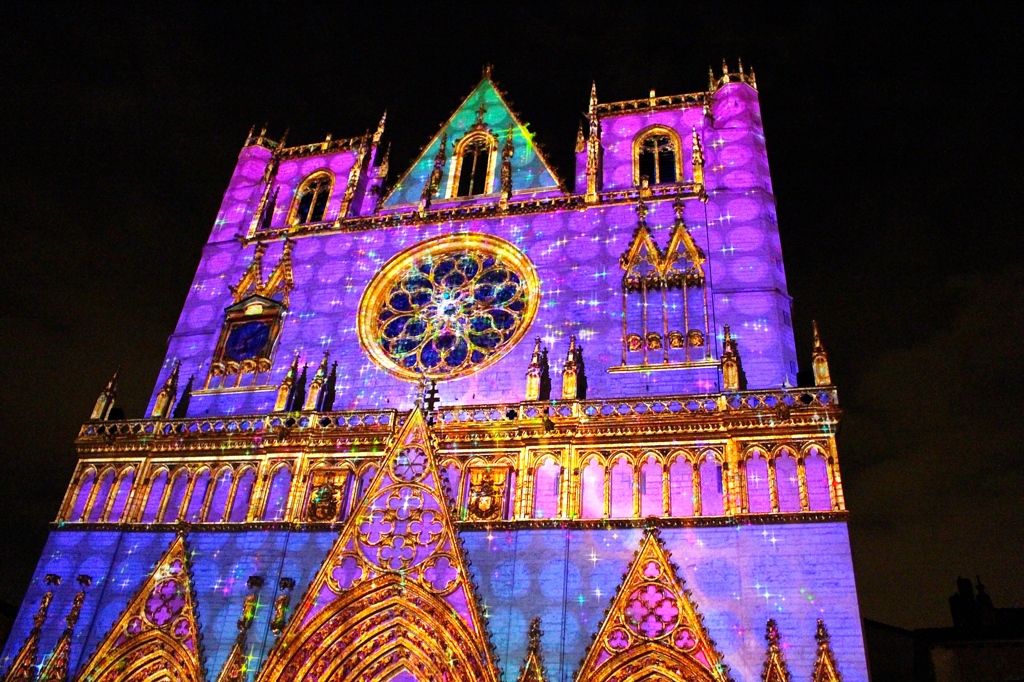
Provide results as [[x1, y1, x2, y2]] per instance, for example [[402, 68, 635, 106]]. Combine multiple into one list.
[[78, 535, 206, 682]]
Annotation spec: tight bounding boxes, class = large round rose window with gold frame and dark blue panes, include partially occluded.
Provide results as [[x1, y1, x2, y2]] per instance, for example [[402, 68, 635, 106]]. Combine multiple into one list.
[[358, 232, 541, 381]]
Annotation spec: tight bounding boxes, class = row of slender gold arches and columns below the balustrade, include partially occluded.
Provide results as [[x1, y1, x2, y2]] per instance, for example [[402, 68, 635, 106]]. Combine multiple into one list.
[[57, 436, 845, 523]]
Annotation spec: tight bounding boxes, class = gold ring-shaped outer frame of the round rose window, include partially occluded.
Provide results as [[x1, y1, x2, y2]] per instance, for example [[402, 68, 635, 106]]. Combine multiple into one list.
[[356, 232, 541, 381]]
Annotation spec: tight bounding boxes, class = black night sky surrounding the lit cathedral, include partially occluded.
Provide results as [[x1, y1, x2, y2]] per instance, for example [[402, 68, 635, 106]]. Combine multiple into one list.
[[0, 2, 1024, 627]]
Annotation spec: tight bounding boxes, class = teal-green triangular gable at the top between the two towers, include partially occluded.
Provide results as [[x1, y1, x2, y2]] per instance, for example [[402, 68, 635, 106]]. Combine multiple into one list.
[[383, 75, 564, 209]]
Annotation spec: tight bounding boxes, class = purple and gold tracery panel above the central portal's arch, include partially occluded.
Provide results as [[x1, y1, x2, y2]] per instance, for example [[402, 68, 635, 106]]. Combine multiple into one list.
[[328, 445, 459, 596]]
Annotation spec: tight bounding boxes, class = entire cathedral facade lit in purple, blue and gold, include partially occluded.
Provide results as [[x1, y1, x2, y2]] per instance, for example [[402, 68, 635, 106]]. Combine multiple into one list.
[[0, 65, 867, 682]]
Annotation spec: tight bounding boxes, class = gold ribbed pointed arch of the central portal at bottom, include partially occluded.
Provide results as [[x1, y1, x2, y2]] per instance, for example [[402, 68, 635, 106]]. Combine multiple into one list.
[[257, 573, 490, 682]]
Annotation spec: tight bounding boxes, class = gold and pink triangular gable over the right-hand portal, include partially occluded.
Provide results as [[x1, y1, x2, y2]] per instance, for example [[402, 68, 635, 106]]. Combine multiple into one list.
[[575, 529, 729, 682]]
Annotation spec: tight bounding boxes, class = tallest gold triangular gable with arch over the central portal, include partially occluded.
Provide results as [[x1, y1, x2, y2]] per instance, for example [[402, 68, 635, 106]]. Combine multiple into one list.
[[258, 410, 498, 682]]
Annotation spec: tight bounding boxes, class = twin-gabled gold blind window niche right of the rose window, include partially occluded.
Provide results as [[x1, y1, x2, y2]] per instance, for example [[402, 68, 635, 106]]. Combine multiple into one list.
[[620, 200, 711, 369]]
